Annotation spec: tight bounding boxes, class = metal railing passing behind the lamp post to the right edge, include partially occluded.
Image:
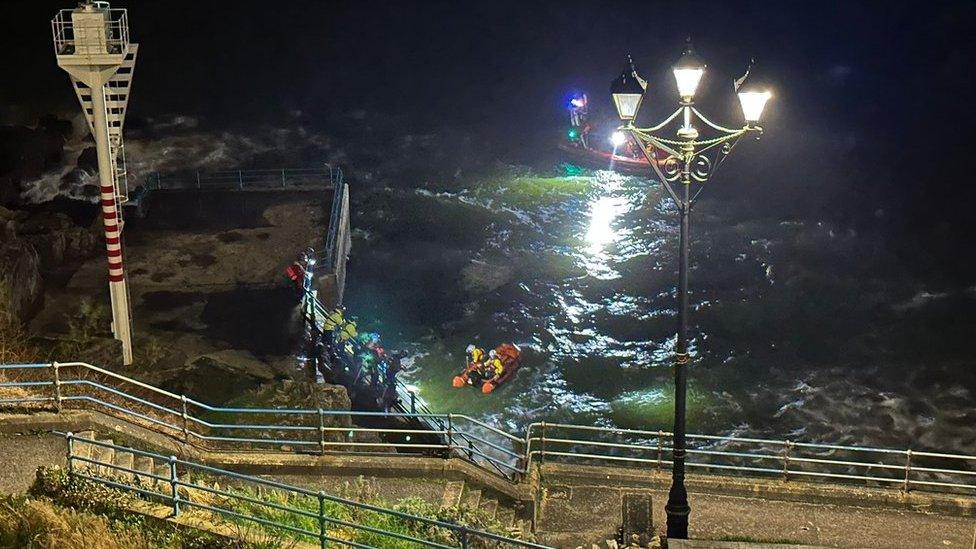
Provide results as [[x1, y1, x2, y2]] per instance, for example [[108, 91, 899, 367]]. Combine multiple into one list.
[[526, 422, 976, 494]]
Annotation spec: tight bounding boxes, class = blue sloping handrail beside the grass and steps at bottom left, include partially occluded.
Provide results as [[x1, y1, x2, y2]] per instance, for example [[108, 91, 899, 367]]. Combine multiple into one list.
[[65, 433, 548, 549]]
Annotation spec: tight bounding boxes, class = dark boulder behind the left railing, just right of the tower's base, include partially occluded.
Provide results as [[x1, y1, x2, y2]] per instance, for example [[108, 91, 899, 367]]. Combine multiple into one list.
[[163, 349, 275, 404]]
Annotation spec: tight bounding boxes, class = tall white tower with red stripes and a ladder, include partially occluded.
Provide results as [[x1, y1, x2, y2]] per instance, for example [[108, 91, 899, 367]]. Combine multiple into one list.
[[51, 1, 138, 364]]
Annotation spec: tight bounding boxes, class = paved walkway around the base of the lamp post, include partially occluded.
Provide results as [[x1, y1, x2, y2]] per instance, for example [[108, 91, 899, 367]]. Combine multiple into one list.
[[537, 482, 976, 549]]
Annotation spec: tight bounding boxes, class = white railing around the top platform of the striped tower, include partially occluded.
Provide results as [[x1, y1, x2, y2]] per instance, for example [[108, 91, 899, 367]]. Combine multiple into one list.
[[51, 8, 129, 55]]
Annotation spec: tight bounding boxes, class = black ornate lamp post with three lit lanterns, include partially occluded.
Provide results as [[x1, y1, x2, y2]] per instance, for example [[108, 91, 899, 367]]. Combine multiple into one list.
[[610, 39, 771, 539]]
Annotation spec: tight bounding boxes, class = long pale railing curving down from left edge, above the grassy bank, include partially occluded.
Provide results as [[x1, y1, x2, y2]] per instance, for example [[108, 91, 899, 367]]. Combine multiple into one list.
[[0, 362, 521, 476]]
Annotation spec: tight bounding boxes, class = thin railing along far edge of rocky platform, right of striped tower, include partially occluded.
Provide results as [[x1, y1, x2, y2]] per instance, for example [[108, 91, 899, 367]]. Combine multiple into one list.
[[145, 165, 342, 191]]
